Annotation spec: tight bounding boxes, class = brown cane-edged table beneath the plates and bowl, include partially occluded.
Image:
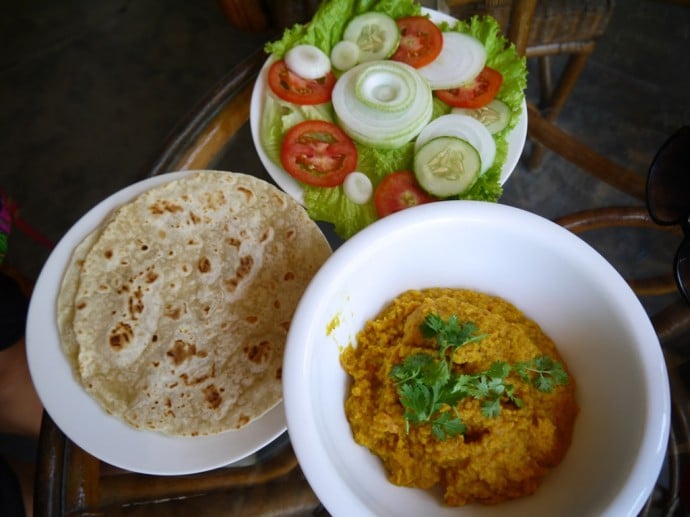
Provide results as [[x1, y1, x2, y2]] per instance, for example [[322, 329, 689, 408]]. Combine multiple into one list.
[[36, 45, 690, 515]]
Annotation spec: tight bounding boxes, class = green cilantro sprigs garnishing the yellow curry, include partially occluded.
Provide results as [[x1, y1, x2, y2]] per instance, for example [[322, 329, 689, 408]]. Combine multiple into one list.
[[390, 314, 568, 440]]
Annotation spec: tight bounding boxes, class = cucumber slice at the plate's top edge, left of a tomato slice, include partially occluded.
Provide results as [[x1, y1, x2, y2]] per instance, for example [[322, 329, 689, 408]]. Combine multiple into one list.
[[343, 11, 400, 63]]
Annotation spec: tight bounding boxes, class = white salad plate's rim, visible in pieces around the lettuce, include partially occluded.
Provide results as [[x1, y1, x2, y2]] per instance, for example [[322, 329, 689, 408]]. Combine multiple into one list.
[[249, 9, 527, 204]]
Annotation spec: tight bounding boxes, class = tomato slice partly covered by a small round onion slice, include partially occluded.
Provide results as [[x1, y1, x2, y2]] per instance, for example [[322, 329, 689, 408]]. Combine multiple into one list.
[[268, 59, 335, 104]]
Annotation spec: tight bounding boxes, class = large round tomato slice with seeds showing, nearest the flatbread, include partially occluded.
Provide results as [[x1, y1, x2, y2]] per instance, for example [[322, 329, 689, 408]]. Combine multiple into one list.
[[280, 120, 357, 187]]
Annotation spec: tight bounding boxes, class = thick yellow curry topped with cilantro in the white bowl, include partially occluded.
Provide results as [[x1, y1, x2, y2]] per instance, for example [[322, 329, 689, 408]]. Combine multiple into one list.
[[341, 288, 578, 506]]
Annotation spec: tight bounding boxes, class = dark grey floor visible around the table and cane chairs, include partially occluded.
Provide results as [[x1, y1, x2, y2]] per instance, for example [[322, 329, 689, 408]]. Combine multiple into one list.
[[0, 0, 690, 510]]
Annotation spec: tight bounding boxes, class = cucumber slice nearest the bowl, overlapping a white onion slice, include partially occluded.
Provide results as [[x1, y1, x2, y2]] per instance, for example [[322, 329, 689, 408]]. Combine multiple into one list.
[[414, 136, 482, 197]]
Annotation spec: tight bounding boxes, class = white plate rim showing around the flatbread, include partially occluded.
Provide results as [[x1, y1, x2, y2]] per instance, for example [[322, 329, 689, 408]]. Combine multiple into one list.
[[26, 171, 286, 475]]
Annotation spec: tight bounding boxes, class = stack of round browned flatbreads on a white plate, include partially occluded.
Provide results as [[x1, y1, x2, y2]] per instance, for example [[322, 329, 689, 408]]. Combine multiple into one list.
[[57, 171, 331, 436]]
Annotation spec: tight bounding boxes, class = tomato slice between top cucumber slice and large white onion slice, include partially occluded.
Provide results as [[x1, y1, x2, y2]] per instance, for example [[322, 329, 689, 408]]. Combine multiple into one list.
[[391, 16, 443, 68]]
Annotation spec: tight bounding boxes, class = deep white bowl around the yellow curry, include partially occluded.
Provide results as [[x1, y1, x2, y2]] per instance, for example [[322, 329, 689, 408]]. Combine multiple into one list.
[[283, 201, 670, 517]]
